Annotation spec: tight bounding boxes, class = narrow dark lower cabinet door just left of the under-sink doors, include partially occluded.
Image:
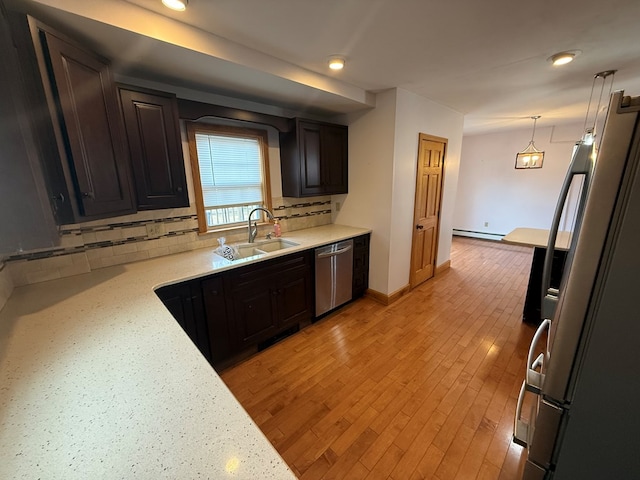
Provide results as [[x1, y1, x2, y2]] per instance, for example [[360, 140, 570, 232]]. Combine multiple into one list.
[[202, 276, 237, 364]]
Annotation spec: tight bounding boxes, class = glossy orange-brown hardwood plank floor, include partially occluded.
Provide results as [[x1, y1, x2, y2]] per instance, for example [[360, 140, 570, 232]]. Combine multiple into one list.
[[221, 237, 534, 480]]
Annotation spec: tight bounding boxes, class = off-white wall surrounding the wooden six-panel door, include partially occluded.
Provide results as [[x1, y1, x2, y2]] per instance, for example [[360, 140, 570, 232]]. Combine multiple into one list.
[[334, 89, 463, 295]]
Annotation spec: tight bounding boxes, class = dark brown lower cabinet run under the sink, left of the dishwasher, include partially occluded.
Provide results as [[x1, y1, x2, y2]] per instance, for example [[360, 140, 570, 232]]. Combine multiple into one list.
[[156, 250, 313, 367]]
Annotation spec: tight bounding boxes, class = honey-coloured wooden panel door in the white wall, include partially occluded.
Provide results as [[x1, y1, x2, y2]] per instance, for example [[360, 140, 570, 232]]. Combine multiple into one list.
[[409, 133, 447, 288]]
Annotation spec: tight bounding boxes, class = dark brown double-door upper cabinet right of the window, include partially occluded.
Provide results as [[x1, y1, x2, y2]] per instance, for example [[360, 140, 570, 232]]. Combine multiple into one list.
[[280, 118, 348, 197]]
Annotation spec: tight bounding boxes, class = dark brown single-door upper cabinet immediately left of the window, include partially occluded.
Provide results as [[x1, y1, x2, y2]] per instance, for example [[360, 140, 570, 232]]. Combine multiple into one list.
[[118, 85, 189, 210]]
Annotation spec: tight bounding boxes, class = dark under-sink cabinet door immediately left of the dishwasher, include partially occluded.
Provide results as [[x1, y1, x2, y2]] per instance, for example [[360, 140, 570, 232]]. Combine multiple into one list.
[[272, 268, 313, 328]]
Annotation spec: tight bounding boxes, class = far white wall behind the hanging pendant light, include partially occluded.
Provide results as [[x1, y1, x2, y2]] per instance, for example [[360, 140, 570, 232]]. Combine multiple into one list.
[[453, 124, 583, 235]]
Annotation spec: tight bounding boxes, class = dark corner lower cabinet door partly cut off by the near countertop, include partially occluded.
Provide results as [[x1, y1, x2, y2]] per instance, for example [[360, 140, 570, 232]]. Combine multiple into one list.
[[156, 282, 211, 362]]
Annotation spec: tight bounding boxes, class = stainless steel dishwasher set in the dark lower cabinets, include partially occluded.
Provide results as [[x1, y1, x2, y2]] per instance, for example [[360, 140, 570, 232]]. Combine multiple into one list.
[[316, 239, 353, 317]]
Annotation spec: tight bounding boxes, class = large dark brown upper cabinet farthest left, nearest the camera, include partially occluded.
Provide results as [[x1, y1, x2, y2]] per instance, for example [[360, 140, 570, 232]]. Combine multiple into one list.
[[11, 12, 136, 224]]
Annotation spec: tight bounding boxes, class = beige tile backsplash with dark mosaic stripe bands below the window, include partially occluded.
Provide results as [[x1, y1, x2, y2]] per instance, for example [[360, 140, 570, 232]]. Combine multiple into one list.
[[5, 197, 331, 286]]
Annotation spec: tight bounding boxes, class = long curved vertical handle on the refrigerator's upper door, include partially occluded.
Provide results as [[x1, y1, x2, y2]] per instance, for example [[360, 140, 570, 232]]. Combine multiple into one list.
[[542, 140, 595, 318]]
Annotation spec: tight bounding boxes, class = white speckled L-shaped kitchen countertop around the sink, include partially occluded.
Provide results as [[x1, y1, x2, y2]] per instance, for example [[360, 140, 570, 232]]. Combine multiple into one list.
[[0, 225, 368, 480]]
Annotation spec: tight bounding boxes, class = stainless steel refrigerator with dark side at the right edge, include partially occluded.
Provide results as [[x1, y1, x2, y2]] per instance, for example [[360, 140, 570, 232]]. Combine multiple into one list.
[[514, 92, 640, 480]]
